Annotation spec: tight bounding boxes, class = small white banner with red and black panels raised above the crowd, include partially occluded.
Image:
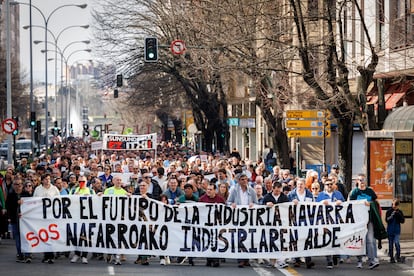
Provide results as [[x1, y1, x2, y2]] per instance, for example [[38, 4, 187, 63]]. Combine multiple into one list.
[[103, 133, 157, 150]]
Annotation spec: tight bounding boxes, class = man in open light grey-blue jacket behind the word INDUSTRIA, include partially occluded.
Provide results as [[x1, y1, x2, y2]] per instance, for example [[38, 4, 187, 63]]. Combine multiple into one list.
[[227, 173, 258, 268]]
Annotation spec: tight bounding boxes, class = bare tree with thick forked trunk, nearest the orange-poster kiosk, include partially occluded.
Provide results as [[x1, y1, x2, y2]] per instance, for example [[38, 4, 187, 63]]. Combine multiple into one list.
[[289, 0, 378, 188]]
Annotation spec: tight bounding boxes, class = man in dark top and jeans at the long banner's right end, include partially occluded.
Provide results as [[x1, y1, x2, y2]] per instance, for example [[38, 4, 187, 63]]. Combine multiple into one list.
[[349, 173, 379, 269]]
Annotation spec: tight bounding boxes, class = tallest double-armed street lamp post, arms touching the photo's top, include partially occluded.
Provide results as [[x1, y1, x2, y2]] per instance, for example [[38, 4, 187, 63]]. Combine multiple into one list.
[[12, 2, 87, 149]]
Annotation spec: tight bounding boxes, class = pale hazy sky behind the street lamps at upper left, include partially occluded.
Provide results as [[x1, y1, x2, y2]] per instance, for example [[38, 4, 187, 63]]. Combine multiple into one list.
[[18, 0, 93, 83]]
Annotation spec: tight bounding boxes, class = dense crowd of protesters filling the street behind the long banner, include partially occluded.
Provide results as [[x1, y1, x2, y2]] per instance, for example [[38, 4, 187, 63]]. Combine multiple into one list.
[[0, 139, 403, 269]]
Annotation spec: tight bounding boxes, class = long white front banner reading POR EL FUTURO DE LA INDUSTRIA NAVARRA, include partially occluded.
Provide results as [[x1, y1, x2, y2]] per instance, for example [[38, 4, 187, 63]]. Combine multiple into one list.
[[20, 195, 368, 258]]
